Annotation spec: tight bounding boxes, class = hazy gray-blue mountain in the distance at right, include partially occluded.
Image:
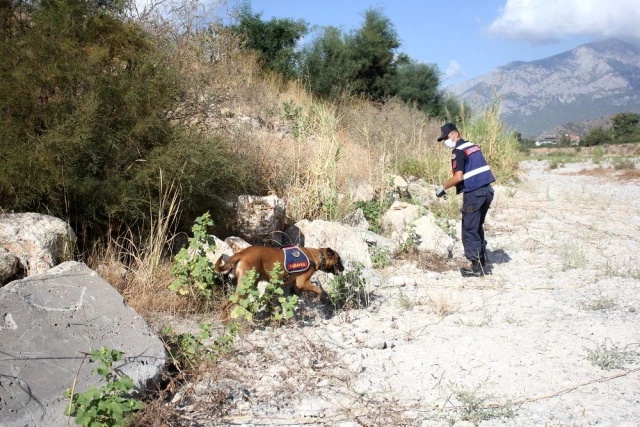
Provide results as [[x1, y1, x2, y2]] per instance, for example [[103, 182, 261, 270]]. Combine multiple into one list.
[[446, 39, 640, 137]]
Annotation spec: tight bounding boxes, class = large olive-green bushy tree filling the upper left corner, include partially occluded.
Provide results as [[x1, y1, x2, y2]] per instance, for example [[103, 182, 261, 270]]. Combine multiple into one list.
[[0, 0, 260, 241]]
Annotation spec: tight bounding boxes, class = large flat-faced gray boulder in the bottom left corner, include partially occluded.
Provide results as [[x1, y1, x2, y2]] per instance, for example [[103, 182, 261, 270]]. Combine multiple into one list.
[[0, 262, 166, 427]]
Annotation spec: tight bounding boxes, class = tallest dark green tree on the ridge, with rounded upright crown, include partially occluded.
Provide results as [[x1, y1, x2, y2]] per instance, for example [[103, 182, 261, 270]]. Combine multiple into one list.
[[347, 9, 408, 100]]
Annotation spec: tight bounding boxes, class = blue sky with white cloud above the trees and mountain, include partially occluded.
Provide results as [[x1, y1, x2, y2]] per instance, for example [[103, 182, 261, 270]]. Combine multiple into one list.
[[226, 0, 640, 86]]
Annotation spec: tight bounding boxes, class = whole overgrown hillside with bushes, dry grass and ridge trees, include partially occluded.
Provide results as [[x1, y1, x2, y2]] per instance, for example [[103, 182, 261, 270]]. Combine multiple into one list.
[[0, 0, 518, 308]]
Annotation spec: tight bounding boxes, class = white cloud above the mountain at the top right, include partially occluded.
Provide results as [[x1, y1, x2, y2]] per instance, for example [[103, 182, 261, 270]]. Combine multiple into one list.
[[488, 0, 640, 44]]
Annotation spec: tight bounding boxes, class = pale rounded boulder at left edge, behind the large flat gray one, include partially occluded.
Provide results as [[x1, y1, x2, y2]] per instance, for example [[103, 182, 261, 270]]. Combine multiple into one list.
[[0, 213, 76, 276]]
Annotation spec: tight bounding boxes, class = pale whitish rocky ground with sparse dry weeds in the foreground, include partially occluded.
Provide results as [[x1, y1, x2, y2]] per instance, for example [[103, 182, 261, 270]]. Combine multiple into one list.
[[158, 161, 640, 427]]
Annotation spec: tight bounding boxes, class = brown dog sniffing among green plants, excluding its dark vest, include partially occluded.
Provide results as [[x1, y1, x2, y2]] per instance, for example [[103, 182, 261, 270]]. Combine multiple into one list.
[[216, 246, 344, 301]]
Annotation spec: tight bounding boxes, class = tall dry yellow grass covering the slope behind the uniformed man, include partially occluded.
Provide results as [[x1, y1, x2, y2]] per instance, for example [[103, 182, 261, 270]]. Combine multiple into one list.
[[142, 23, 517, 226]]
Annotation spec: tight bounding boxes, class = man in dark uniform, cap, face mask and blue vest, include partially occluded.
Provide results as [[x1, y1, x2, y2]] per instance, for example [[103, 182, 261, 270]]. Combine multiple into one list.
[[436, 123, 495, 277]]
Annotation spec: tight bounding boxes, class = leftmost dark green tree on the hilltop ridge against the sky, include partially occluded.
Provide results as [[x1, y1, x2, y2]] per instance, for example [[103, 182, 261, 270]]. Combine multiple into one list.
[[233, 3, 308, 78]]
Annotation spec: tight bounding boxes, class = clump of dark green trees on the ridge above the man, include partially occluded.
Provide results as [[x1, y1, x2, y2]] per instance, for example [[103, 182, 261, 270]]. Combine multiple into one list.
[[301, 9, 456, 121]]
